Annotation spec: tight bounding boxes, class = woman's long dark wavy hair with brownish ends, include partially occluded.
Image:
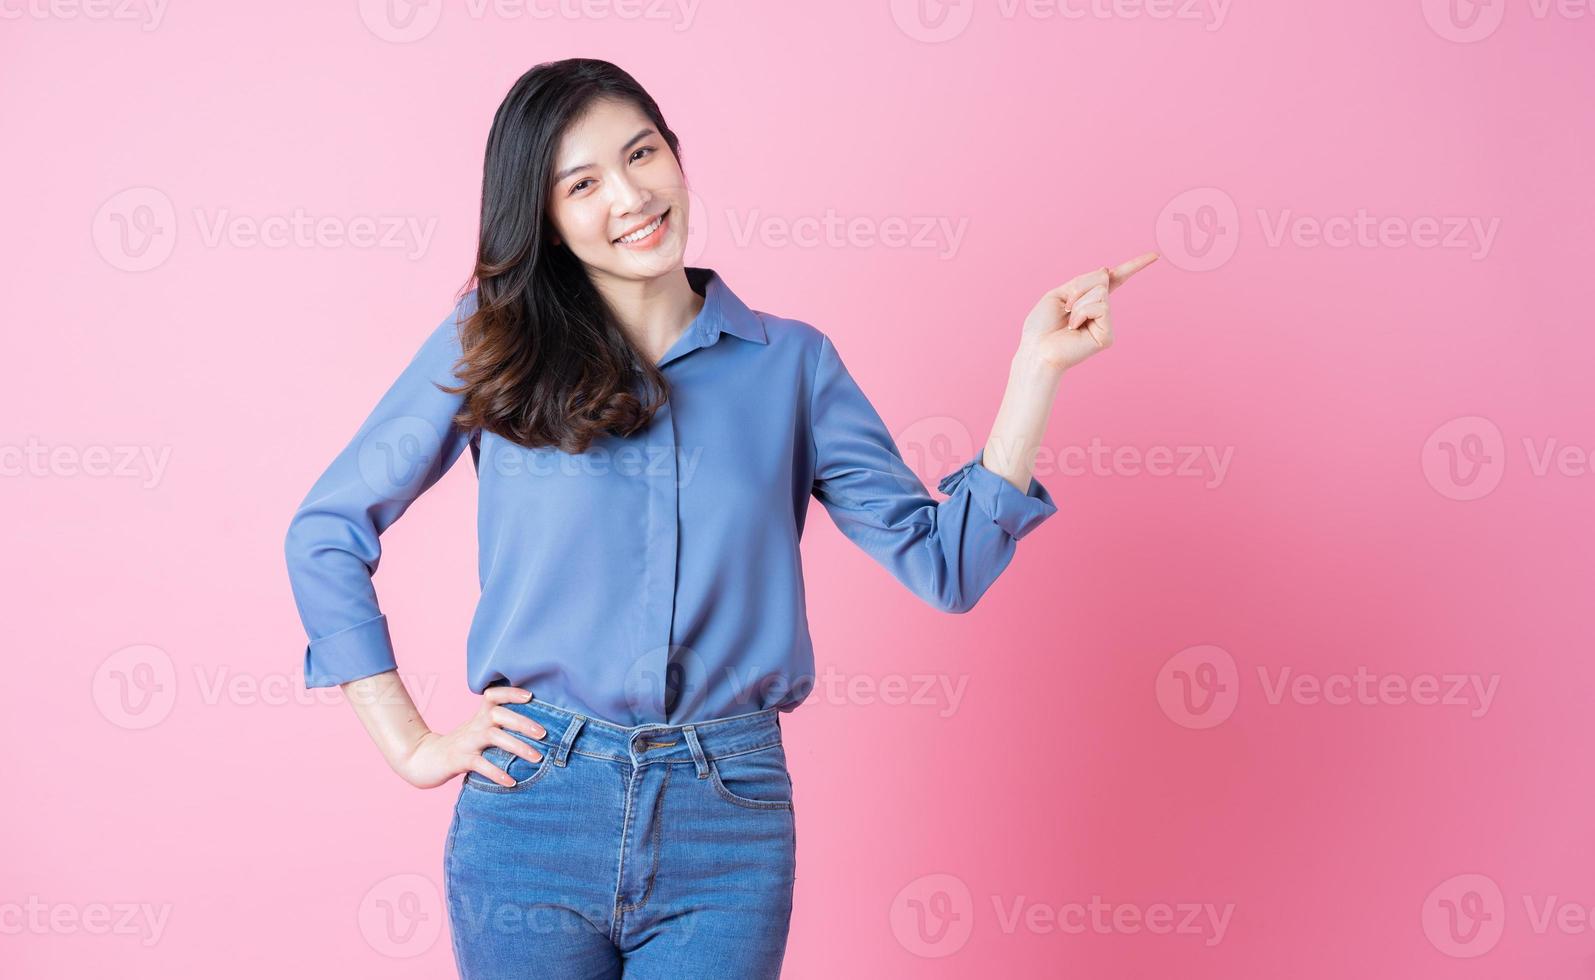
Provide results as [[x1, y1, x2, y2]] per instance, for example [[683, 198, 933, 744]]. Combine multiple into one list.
[[439, 57, 681, 453]]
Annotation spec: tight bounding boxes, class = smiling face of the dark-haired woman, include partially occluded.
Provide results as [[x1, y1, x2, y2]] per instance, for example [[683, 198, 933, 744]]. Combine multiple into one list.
[[549, 99, 687, 279]]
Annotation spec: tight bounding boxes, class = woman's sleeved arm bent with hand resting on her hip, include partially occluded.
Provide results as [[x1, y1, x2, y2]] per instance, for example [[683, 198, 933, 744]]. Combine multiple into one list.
[[284, 292, 555, 787]]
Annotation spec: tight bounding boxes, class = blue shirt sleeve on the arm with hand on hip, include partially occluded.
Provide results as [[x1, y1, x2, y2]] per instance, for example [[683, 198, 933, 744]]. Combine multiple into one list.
[[284, 292, 475, 688]]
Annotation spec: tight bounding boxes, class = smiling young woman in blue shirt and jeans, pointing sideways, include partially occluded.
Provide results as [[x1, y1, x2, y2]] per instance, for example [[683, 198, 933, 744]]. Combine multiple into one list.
[[286, 59, 1156, 980]]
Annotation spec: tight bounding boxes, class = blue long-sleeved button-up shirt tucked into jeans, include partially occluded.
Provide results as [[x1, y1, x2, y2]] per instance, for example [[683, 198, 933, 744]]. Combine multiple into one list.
[[286, 267, 1057, 726]]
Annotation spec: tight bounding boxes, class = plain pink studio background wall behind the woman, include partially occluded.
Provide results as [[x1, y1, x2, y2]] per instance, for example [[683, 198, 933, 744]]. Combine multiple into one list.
[[0, 0, 1595, 978]]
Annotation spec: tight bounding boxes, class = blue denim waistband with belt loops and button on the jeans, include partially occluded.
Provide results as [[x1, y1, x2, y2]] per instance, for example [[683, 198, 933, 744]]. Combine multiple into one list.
[[491, 697, 782, 774]]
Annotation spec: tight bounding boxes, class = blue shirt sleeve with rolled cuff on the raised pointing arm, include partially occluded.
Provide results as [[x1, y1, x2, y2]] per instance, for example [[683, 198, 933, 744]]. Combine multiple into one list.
[[810, 337, 1057, 613]]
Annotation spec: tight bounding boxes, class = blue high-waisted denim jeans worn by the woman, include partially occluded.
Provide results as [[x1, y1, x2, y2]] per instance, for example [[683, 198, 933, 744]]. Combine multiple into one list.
[[443, 699, 798, 980]]
